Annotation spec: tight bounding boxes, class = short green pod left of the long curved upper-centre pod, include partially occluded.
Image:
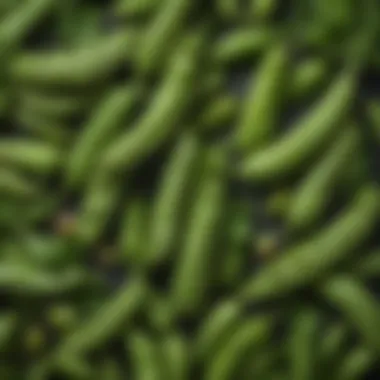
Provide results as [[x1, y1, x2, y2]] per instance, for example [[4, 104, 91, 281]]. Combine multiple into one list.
[[66, 85, 141, 187]]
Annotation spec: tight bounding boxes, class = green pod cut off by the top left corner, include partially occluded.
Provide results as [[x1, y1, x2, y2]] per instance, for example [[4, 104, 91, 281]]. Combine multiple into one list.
[[0, 0, 55, 55]]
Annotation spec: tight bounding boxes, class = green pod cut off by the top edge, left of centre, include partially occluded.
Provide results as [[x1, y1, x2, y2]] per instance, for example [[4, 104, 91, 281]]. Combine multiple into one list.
[[136, 0, 192, 74]]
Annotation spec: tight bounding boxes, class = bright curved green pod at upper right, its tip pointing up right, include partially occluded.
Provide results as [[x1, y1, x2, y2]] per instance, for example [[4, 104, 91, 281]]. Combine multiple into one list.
[[240, 70, 356, 181]]
